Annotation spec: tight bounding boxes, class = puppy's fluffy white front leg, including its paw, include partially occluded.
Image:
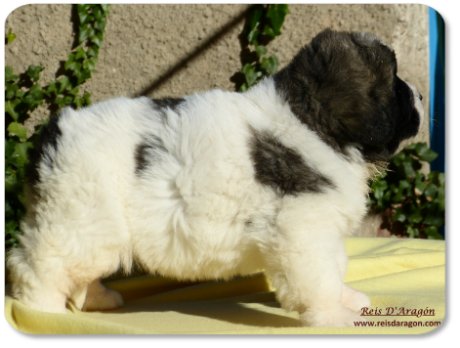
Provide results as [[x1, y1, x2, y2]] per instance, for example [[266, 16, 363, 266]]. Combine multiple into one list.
[[264, 200, 365, 327]]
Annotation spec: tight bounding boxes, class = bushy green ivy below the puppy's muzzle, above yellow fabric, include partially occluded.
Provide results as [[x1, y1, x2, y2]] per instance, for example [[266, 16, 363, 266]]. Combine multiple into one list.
[[369, 143, 445, 239]]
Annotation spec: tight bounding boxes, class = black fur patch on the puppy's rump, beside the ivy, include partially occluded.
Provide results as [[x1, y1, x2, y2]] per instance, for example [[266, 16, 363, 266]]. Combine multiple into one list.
[[25, 113, 62, 188]]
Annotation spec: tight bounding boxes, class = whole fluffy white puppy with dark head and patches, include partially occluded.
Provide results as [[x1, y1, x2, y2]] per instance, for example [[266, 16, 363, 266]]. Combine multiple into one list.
[[8, 30, 423, 326]]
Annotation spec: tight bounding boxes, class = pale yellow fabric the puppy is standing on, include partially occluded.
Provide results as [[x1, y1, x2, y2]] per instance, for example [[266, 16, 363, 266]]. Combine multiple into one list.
[[5, 238, 445, 334]]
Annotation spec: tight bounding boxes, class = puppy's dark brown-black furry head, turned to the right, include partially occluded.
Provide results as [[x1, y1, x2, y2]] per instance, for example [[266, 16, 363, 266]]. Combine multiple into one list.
[[275, 30, 424, 162]]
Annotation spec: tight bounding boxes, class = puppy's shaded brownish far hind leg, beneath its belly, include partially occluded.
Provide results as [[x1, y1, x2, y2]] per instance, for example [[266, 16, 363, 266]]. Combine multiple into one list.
[[82, 279, 124, 311]]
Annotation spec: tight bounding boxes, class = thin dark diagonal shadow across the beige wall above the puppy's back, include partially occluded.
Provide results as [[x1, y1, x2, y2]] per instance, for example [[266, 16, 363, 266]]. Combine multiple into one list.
[[134, 5, 254, 97]]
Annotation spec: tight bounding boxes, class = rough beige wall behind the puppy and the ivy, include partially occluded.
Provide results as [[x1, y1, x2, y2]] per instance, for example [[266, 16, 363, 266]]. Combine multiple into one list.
[[5, 4, 429, 145]]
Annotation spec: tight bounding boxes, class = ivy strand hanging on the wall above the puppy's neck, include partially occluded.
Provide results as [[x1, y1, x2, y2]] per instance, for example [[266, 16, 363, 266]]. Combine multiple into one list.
[[237, 4, 289, 92]]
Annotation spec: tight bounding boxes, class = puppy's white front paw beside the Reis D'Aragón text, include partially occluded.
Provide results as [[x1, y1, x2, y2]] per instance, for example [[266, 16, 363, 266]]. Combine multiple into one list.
[[300, 306, 367, 327]]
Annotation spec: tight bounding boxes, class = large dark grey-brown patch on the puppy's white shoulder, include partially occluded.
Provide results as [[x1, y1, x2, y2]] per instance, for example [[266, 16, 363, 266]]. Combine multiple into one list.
[[251, 131, 334, 195]]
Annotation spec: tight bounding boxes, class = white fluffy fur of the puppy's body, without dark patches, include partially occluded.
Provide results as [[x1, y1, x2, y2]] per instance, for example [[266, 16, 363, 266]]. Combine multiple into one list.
[[9, 78, 423, 326]]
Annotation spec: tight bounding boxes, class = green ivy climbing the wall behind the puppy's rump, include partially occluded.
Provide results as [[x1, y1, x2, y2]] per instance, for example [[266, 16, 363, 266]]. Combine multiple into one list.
[[5, 4, 109, 256]]
